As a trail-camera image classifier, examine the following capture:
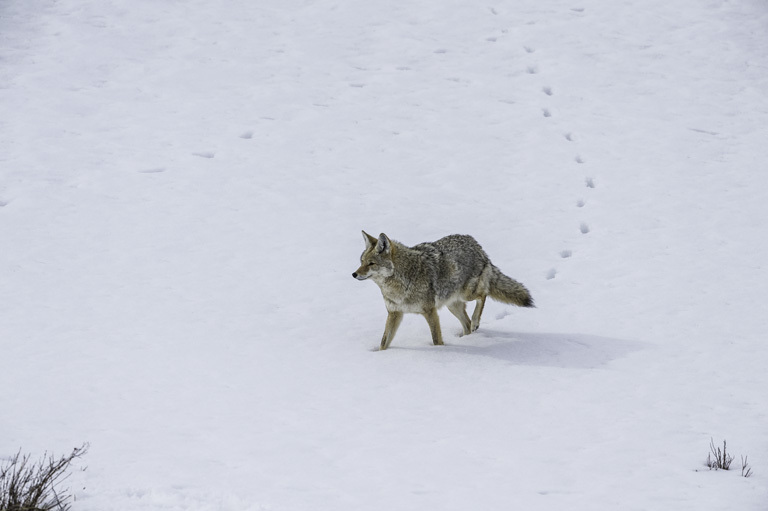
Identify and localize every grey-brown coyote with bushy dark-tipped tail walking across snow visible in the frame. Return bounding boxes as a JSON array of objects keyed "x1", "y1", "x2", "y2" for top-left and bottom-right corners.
[{"x1": 352, "y1": 231, "x2": 534, "y2": 350}]
